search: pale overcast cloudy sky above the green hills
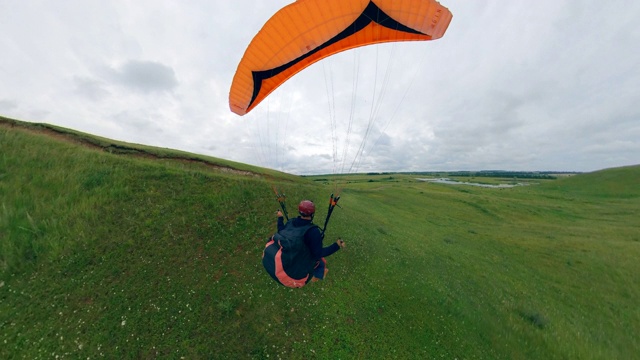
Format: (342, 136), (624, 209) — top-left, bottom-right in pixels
(0, 0), (640, 174)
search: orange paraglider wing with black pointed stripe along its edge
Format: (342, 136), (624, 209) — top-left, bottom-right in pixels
(229, 0), (452, 115)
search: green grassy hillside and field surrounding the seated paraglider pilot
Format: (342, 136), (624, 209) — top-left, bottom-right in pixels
(0, 119), (640, 359)
